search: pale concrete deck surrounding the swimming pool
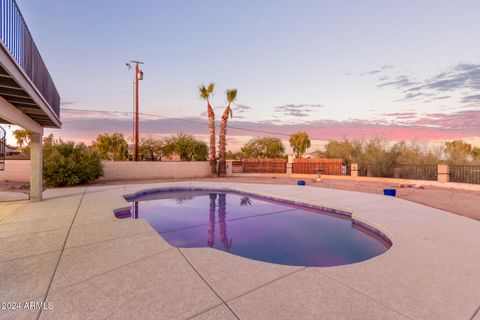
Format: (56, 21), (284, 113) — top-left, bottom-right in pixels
(0, 181), (480, 320)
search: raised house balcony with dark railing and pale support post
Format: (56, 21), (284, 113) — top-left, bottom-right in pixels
(0, 0), (61, 201)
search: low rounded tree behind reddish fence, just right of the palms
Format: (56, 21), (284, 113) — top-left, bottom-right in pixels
(241, 137), (285, 158)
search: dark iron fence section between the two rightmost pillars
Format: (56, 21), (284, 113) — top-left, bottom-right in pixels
(358, 163), (437, 180)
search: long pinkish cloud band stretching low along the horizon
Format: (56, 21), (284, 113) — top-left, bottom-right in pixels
(47, 110), (480, 143)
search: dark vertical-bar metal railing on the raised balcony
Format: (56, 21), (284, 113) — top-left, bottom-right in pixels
(0, 0), (60, 116)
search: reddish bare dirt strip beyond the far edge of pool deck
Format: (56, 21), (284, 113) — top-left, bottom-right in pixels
(0, 177), (480, 221)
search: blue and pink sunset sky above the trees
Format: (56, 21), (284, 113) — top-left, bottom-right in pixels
(5, 0), (480, 150)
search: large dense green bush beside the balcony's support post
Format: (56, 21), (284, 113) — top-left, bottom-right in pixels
(43, 140), (103, 187)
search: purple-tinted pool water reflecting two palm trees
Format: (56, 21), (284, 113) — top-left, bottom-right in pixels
(116, 191), (390, 267)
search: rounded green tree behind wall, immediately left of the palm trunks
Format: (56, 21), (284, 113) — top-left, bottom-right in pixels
(163, 133), (208, 161)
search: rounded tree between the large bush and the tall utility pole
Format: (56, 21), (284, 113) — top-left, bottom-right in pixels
(93, 133), (128, 161)
